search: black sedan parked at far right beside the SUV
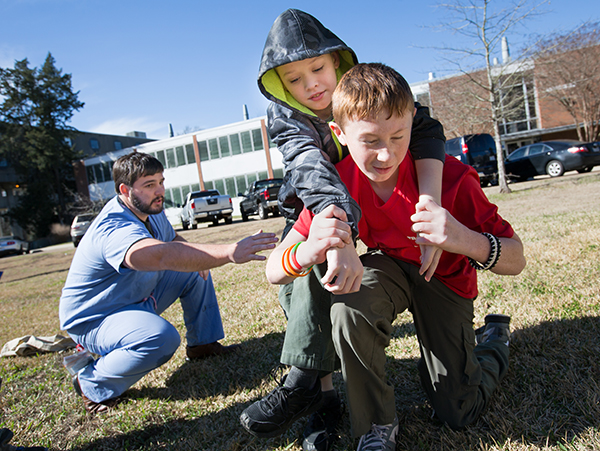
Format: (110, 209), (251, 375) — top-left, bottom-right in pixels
(504, 140), (600, 181)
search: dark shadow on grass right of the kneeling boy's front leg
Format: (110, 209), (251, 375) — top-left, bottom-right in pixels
(387, 317), (600, 450)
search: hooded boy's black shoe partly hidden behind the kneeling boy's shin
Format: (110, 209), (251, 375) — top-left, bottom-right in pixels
(302, 395), (344, 451)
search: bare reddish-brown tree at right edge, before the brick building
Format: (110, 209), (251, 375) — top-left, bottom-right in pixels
(534, 22), (600, 141)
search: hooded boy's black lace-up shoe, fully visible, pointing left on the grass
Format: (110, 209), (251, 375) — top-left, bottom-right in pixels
(240, 376), (323, 438)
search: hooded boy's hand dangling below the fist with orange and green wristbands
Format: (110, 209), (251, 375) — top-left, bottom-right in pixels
(321, 246), (364, 294)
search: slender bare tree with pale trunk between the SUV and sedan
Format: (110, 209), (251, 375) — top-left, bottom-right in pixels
(432, 0), (547, 193)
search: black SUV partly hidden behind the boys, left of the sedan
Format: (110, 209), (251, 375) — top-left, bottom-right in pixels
(446, 133), (498, 186)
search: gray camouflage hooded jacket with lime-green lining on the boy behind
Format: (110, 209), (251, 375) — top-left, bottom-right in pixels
(258, 9), (445, 236)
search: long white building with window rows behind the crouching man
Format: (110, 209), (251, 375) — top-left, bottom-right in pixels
(83, 117), (283, 224)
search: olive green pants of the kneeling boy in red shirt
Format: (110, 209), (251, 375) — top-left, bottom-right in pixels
(331, 251), (509, 436)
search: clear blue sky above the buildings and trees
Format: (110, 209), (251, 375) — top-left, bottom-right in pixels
(0, 0), (600, 139)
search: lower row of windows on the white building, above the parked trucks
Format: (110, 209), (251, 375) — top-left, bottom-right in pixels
(165, 169), (283, 207)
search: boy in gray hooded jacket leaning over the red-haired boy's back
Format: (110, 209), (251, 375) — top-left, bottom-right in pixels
(240, 9), (445, 450)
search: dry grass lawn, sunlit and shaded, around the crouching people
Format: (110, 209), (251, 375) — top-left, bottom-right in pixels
(0, 171), (600, 451)
